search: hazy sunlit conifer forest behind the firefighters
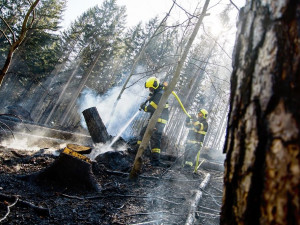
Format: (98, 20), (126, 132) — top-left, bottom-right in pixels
(0, 0), (237, 158)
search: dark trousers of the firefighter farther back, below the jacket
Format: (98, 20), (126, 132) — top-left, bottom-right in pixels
(183, 143), (202, 171)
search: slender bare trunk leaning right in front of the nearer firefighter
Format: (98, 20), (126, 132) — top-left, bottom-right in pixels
(130, 0), (209, 179)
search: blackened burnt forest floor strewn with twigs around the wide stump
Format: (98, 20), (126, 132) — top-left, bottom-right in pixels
(0, 147), (223, 225)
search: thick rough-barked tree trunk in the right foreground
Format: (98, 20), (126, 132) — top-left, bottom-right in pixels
(221, 0), (300, 225)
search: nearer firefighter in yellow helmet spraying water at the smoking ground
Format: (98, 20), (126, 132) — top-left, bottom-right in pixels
(137, 77), (169, 166)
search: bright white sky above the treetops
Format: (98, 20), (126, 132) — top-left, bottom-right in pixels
(62, 0), (245, 28)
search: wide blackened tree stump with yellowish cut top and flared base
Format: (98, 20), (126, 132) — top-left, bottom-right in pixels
(29, 148), (101, 192)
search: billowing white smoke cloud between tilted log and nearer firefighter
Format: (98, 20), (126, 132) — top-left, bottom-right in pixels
(77, 75), (148, 138)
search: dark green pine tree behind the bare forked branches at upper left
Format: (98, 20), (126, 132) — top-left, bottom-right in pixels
(0, 0), (65, 109)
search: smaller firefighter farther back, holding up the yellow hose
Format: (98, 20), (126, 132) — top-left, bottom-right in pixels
(183, 109), (208, 173)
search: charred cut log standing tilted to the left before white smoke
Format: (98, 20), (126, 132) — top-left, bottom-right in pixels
(82, 107), (110, 143)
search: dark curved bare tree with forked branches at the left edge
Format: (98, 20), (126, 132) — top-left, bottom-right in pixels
(0, 0), (40, 87)
